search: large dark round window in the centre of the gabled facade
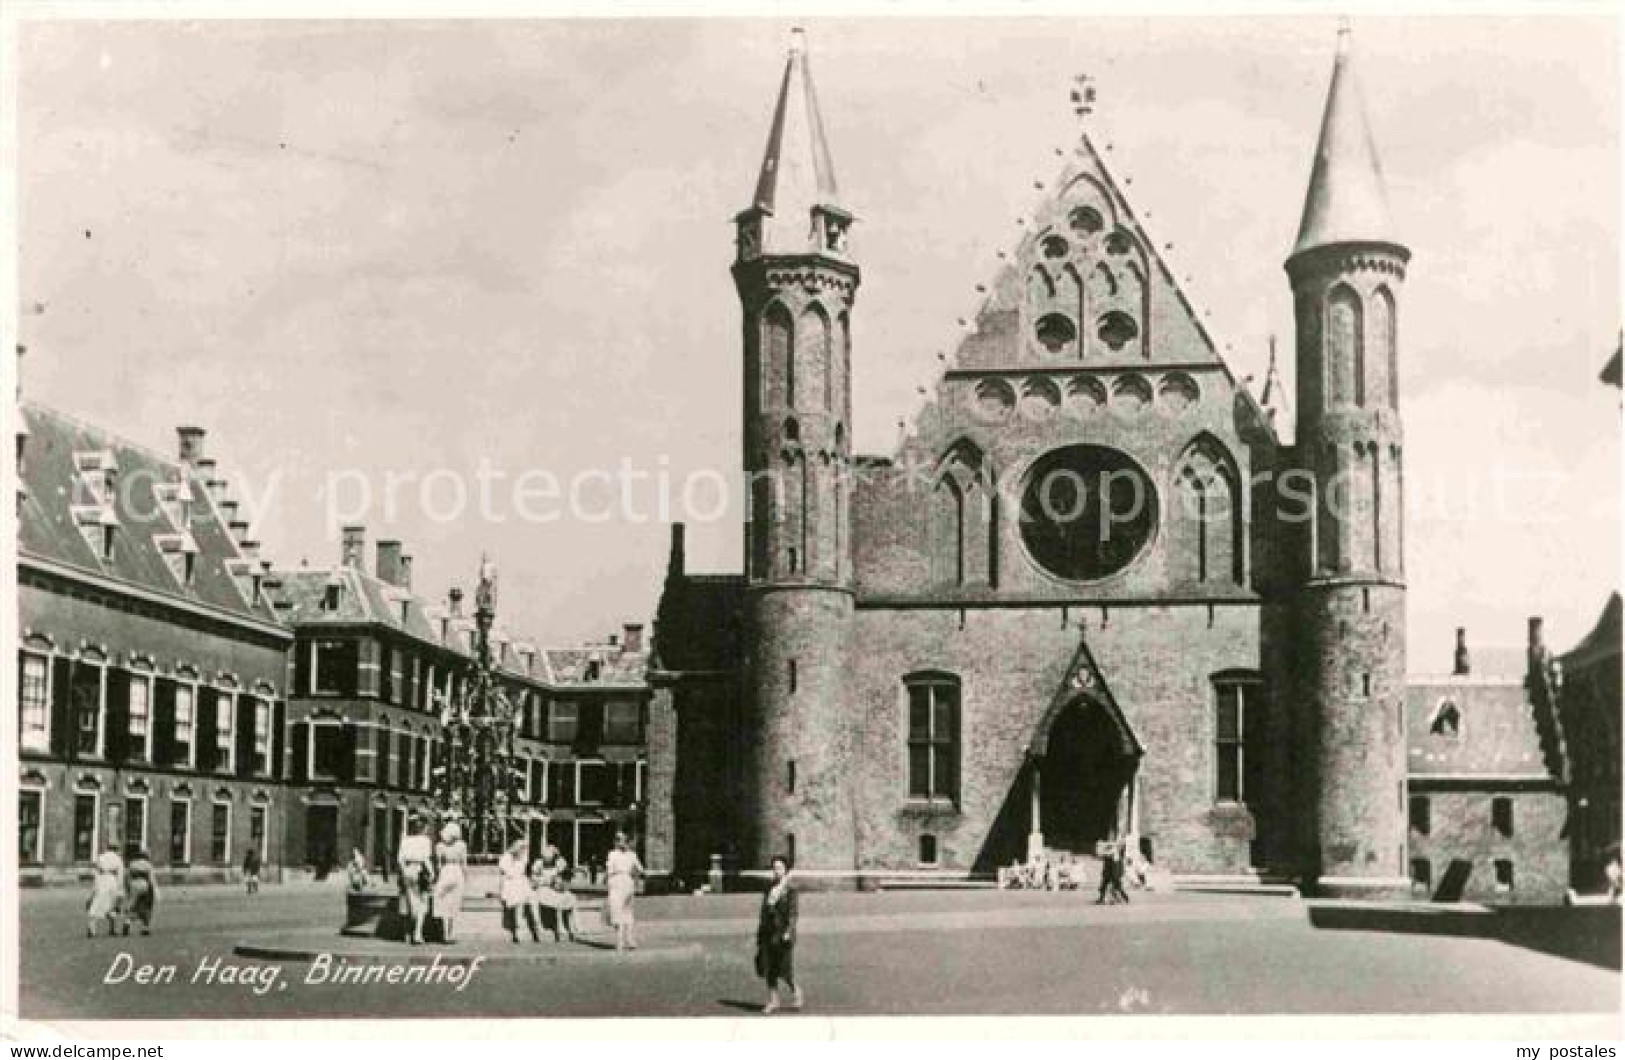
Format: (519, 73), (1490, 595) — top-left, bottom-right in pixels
(1021, 445), (1157, 582)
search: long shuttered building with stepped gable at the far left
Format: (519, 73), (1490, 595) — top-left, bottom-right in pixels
(16, 411), (293, 886)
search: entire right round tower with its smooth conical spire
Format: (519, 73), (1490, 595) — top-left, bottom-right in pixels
(1285, 26), (1411, 896)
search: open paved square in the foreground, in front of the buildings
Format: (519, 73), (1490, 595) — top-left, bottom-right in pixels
(9, 884), (1620, 1019)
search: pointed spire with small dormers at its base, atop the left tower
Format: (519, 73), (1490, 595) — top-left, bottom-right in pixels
(741, 28), (850, 254)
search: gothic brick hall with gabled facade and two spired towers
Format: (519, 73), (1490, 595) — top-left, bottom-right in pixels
(652, 29), (1411, 894)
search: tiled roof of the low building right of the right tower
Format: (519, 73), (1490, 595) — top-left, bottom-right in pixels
(1406, 676), (1552, 777)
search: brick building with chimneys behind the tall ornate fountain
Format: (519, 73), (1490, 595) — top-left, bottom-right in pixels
(278, 527), (648, 876)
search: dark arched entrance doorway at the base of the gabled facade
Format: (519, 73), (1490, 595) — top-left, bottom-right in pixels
(1027, 693), (1142, 855)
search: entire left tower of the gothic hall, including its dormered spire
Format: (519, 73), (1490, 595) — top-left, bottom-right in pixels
(733, 29), (858, 870)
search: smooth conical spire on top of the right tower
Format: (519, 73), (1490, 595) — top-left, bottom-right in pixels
(1292, 23), (1398, 255)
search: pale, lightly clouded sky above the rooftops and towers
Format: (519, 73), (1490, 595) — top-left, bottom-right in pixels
(16, 16), (1620, 671)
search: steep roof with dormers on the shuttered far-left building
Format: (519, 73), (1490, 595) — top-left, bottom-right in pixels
(18, 403), (276, 623)
